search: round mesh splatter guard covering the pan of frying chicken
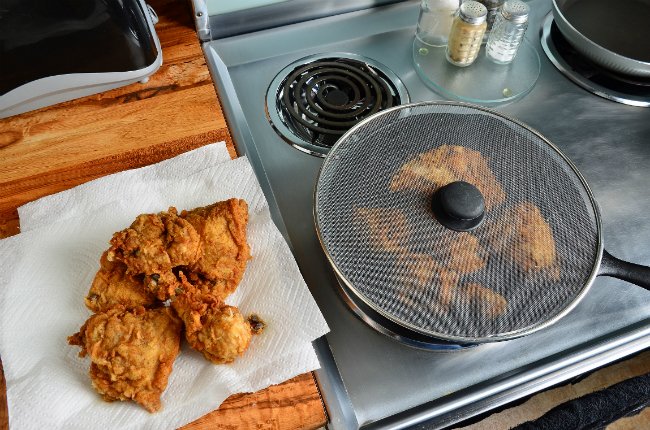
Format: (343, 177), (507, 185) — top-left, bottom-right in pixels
(315, 102), (602, 343)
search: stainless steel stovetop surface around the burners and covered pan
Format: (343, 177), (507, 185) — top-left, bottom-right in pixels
(204, 0), (650, 429)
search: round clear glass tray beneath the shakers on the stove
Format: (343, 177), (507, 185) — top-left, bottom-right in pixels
(413, 38), (540, 105)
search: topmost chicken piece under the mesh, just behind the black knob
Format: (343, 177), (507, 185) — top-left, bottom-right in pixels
(390, 145), (506, 210)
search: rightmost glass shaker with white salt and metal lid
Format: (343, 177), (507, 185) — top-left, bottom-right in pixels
(485, 0), (529, 64)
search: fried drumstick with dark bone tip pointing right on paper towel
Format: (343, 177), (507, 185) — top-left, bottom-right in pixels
(172, 277), (254, 364)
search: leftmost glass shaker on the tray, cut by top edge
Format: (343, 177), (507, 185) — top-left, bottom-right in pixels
(415, 0), (460, 47)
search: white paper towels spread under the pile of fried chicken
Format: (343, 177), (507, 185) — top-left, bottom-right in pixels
(0, 146), (328, 429)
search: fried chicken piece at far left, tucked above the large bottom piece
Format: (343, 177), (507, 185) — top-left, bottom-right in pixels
(84, 251), (157, 312)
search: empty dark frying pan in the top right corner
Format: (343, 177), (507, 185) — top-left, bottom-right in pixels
(553, 0), (650, 78)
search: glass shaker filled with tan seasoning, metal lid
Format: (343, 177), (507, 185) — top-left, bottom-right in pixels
(446, 0), (487, 67)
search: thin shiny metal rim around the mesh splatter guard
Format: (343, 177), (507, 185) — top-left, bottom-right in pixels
(313, 101), (603, 344)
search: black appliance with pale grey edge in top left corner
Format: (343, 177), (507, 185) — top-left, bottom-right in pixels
(0, 0), (162, 118)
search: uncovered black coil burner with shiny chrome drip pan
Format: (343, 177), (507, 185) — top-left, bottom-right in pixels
(266, 54), (409, 157)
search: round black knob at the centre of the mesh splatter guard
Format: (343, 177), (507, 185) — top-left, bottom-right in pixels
(431, 181), (485, 231)
